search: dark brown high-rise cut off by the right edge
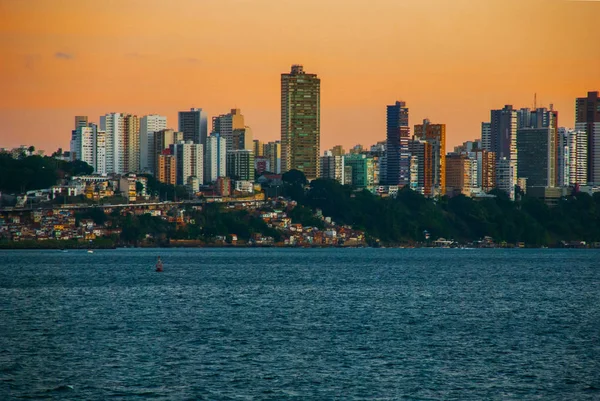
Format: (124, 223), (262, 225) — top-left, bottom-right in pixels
(575, 92), (600, 185)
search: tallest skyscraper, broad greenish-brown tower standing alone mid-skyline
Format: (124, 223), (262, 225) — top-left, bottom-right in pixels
(281, 65), (321, 180)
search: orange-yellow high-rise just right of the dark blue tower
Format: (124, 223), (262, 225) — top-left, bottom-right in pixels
(414, 119), (446, 195)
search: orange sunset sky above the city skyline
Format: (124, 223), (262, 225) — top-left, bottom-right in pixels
(0, 0), (600, 152)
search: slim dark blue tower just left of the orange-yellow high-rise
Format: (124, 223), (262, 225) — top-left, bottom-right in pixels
(385, 101), (410, 186)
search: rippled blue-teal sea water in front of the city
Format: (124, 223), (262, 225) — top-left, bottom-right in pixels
(0, 249), (600, 400)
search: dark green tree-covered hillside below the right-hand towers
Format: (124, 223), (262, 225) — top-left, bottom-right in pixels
(284, 170), (600, 246)
